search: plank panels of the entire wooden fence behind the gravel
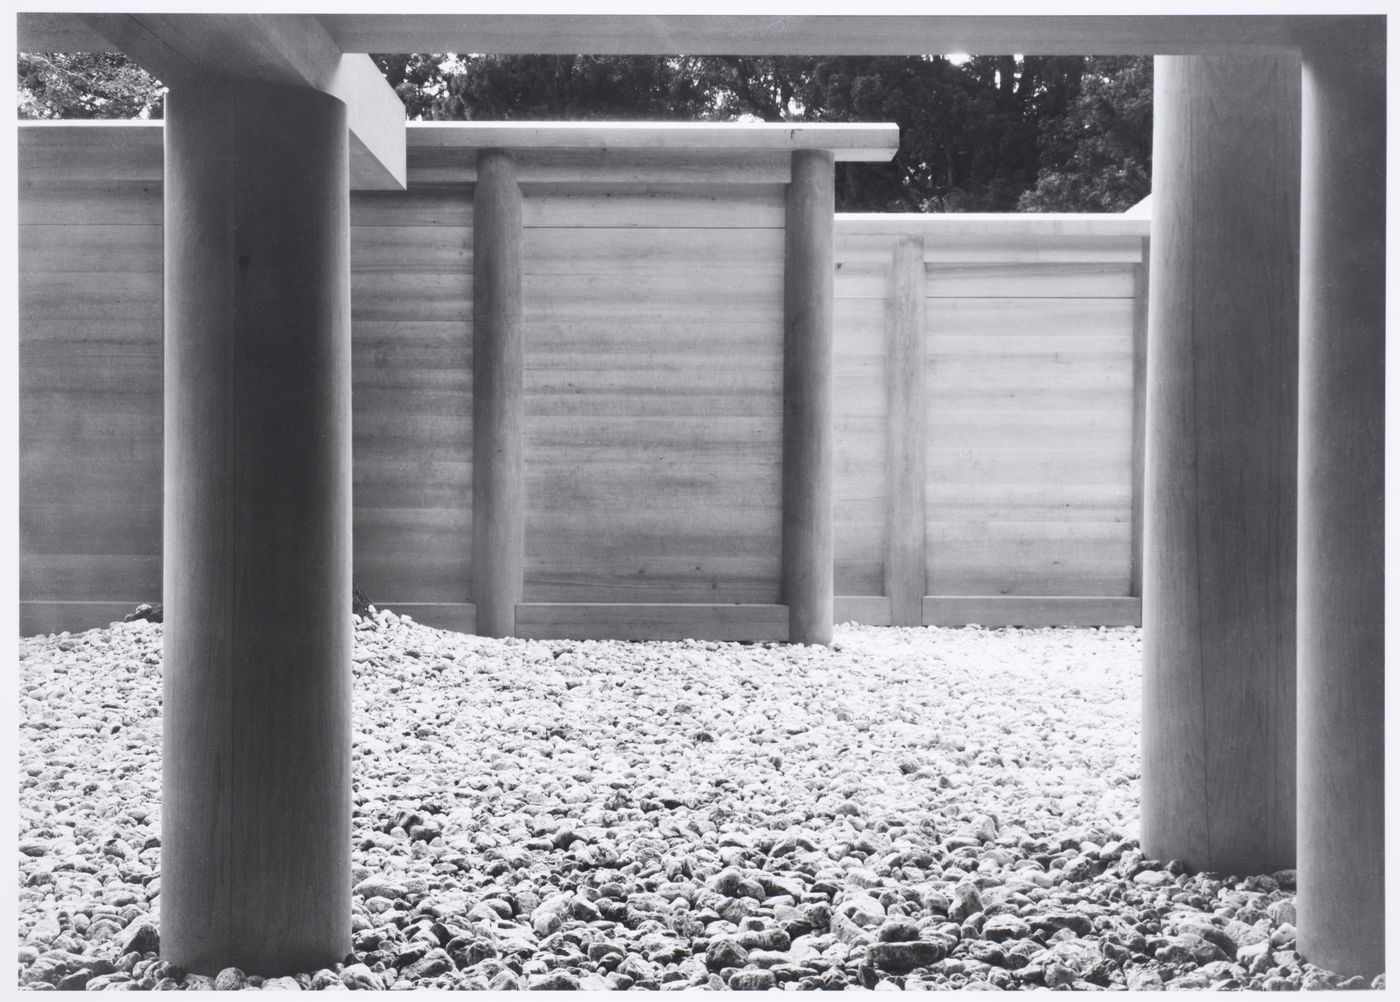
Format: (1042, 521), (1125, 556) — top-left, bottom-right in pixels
(20, 126), (1147, 640)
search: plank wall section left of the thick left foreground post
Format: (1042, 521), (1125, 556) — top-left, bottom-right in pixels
(18, 129), (164, 634)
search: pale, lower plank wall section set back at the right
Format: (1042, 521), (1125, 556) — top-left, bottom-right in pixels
(836, 216), (1147, 626)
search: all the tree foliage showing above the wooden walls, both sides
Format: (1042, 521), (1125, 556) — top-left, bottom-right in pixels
(20, 53), (1152, 211)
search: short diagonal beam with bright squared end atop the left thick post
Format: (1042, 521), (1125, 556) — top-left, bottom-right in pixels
(73, 14), (406, 189)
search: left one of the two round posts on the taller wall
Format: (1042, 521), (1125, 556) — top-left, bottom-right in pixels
(472, 150), (525, 637)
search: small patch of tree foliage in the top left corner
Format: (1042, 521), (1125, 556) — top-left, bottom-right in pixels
(18, 52), (165, 119)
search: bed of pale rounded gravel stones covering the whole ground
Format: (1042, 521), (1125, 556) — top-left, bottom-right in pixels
(18, 612), (1383, 989)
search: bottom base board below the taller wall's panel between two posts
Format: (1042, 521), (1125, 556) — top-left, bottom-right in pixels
(515, 602), (788, 642)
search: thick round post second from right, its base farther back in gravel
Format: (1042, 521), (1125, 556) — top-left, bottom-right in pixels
(1141, 55), (1299, 873)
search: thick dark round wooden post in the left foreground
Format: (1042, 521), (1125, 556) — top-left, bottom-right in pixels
(161, 84), (353, 975)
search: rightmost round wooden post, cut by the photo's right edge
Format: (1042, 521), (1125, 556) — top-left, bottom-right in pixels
(1298, 17), (1386, 975)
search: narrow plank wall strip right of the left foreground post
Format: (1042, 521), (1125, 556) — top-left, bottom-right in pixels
(350, 183), (476, 630)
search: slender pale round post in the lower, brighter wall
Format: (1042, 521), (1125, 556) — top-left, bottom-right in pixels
(885, 237), (928, 626)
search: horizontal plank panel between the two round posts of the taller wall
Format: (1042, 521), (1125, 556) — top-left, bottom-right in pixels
(524, 178), (784, 619)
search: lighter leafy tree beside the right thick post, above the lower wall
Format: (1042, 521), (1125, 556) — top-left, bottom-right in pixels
(1016, 56), (1152, 213)
